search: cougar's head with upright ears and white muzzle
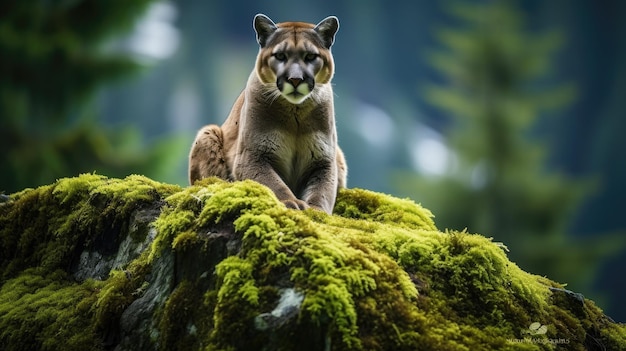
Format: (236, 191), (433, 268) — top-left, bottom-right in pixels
(254, 14), (339, 104)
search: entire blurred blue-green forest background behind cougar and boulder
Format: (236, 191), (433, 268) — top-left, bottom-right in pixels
(0, 0), (626, 322)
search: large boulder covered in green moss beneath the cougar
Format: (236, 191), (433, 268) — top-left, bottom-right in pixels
(0, 174), (626, 351)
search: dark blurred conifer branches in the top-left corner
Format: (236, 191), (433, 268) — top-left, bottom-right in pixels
(0, 0), (151, 115)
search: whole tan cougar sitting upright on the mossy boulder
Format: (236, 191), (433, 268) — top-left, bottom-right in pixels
(189, 15), (347, 213)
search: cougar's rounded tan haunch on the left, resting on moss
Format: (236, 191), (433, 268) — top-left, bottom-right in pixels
(189, 124), (232, 184)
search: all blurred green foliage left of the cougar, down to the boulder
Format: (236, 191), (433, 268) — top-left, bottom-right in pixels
(0, 0), (187, 192)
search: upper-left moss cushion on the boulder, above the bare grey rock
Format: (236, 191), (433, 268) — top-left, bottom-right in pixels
(0, 174), (180, 279)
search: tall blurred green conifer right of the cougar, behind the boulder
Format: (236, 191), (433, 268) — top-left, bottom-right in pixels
(394, 1), (626, 302)
